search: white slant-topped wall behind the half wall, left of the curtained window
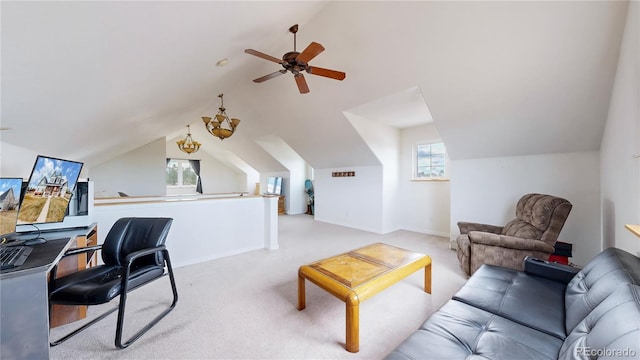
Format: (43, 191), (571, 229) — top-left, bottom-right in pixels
(88, 138), (167, 196)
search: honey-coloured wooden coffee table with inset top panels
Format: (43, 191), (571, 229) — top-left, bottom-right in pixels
(298, 243), (431, 353)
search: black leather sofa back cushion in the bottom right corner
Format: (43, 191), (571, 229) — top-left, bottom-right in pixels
(558, 285), (640, 360)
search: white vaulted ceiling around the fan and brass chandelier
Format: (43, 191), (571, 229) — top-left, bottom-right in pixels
(0, 1), (627, 171)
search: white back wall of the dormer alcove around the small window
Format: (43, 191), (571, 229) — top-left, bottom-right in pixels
(397, 124), (451, 238)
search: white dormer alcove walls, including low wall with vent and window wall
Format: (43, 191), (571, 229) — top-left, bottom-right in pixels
(314, 122), (450, 237)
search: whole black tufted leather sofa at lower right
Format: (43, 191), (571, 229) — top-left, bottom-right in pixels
(387, 248), (640, 360)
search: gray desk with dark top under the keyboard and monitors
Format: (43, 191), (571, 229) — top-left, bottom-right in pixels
(0, 224), (95, 360)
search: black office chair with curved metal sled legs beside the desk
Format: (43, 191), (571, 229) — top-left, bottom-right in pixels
(49, 217), (178, 349)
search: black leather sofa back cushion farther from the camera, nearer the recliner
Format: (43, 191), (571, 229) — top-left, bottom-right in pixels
(565, 248), (640, 333)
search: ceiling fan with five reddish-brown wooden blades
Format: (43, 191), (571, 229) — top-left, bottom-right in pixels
(244, 24), (346, 94)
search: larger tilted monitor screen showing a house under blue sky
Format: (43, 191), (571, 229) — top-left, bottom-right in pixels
(17, 155), (83, 225)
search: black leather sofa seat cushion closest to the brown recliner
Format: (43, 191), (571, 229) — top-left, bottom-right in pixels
(453, 265), (566, 339)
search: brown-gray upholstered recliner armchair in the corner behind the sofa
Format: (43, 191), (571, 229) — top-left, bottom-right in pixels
(457, 194), (573, 275)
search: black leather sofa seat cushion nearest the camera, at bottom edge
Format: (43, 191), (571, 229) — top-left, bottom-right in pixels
(386, 300), (562, 360)
